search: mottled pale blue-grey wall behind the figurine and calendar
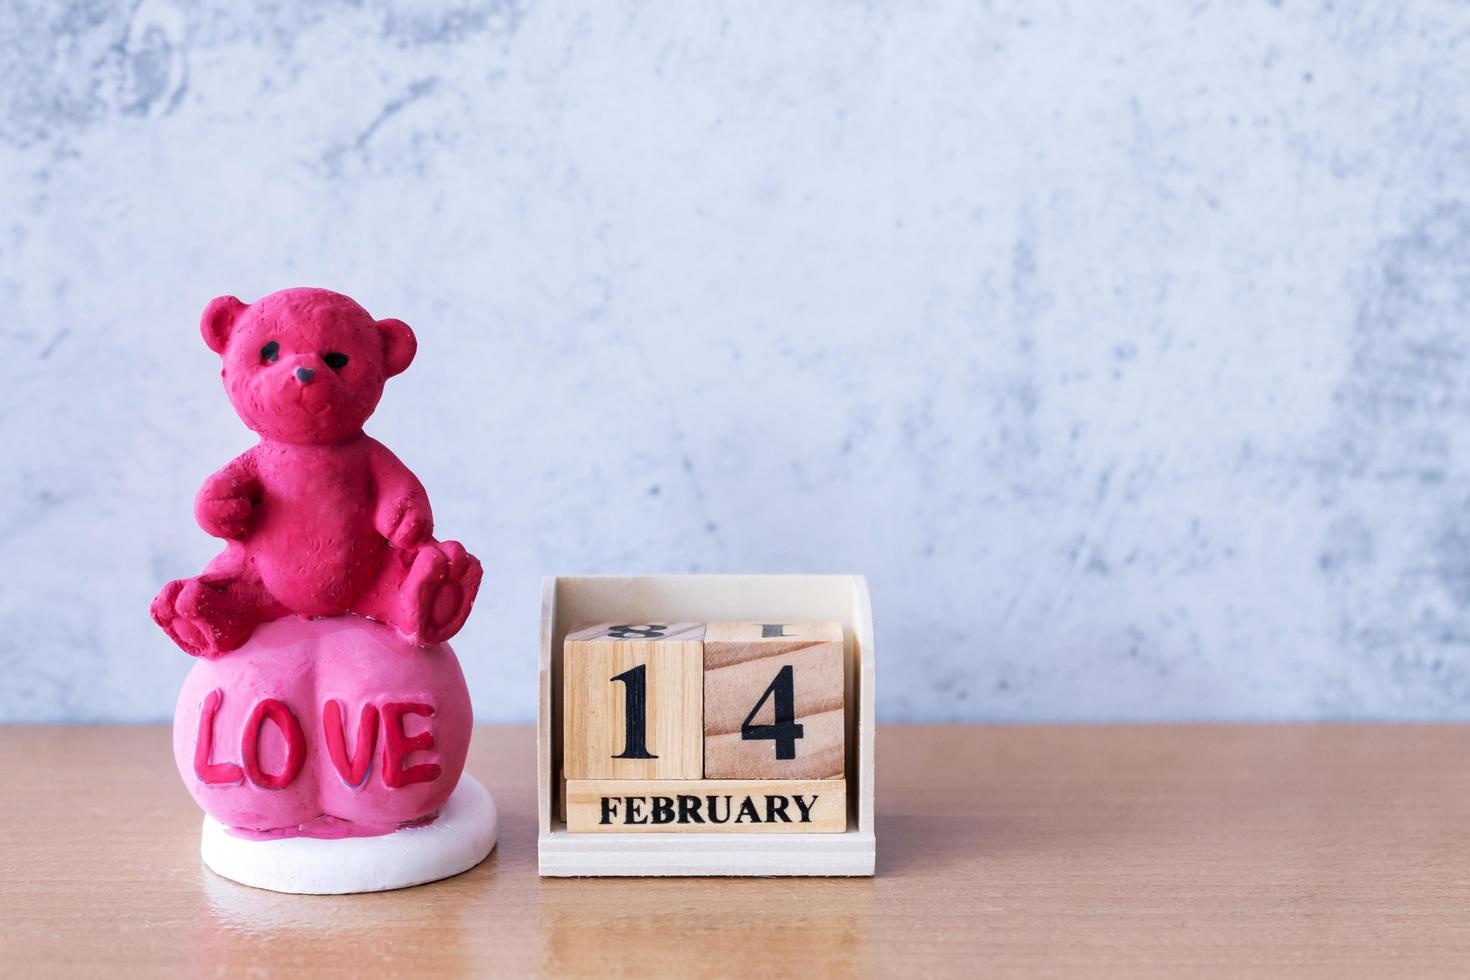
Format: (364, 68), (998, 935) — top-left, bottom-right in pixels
(0, 0), (1470, 720)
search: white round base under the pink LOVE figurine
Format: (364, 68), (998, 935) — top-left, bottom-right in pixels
(198, 774), (495, 895)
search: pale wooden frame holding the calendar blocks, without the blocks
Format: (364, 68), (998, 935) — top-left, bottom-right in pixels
(537, 574), (876, 877)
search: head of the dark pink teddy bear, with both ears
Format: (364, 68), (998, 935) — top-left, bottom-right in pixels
(200, 288), (417, 444)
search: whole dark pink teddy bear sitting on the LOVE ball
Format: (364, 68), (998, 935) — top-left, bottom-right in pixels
(151, 289), (481, 658)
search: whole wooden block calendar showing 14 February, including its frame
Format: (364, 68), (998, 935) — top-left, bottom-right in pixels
(538, 576), (875, 876)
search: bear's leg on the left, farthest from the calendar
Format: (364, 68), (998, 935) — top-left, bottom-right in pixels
(150, 551), (287, 658)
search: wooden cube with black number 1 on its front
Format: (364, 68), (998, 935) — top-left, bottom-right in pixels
(562, 623), (704, 780)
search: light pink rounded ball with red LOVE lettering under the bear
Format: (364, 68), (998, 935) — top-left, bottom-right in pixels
(173, 616), (473, 837)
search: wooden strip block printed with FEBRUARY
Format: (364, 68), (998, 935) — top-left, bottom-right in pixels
(564, 779), (847, 833)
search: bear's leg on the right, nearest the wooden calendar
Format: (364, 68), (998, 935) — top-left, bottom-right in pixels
(354, 541), (482, 646)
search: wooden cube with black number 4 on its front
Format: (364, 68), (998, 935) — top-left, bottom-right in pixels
(704, 623), (847, 779)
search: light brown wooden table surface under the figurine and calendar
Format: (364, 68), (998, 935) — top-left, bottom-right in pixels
(0, 726), (1470, 977)
